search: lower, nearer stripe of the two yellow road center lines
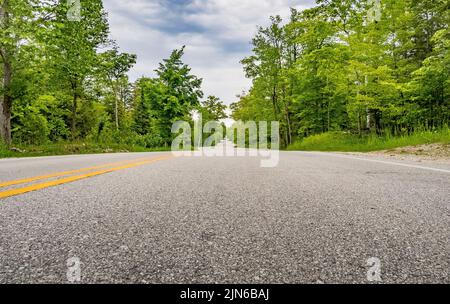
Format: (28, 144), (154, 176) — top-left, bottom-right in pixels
(0, 156), (173, 199)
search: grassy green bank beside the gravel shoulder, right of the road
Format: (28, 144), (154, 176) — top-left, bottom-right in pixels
(287, 128), (450, 152)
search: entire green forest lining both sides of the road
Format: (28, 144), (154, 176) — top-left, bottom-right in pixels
(0, 0), (450, 156)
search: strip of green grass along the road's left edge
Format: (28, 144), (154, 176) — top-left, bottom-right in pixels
(0, 142), (170, 158)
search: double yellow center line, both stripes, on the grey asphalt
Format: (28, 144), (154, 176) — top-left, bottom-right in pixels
(0, 155), (173, 199)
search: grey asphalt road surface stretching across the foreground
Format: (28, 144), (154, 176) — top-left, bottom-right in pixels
(0, 152), (450, 283)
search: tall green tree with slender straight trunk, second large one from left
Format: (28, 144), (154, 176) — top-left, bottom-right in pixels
(46, 0), (109, 138)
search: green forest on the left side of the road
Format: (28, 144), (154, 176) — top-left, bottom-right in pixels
(0, 0), (226, 152)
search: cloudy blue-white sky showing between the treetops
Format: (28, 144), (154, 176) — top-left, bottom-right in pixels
(104, 0), (314, 104)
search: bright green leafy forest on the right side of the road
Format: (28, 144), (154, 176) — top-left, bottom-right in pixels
(231, 0), (450, 147)
